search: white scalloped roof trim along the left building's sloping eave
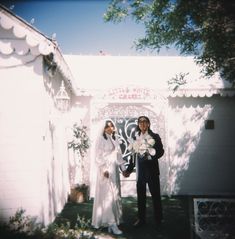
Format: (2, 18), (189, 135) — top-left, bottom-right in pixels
(0, 4), (77, 94)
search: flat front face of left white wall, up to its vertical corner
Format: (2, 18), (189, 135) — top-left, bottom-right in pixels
(0, 54), (44, 220)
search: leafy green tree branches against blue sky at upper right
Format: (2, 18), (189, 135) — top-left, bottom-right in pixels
(104, 0), (235, 86)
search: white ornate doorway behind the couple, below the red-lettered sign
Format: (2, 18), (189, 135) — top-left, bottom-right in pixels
(90, 101), (169, 197)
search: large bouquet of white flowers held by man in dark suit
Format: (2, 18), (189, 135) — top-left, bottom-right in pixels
(128, 135), (156, 156)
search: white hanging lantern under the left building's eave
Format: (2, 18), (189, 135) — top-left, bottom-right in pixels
(55, 80), (70, 112)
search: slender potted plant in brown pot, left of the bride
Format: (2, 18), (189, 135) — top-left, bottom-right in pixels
(68, 124), (90, 203)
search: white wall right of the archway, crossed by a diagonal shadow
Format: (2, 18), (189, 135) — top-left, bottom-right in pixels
(169, 96), (235, 195)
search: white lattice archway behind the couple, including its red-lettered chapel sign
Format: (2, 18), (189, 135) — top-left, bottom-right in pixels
(90, 86), (169, 196)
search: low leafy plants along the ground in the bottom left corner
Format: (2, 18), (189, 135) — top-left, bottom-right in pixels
(0, 209), (94, 239)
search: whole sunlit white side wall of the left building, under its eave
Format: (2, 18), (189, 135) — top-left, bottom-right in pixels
(0, 23), (73, 224)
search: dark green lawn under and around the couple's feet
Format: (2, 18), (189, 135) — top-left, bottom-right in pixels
(55, 197), (191, 239)
